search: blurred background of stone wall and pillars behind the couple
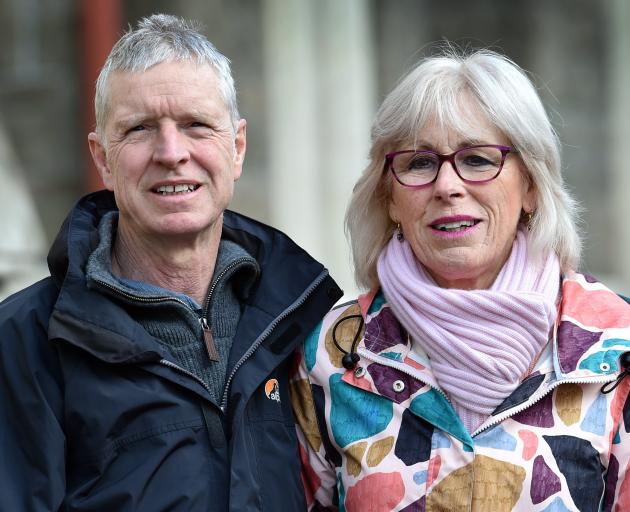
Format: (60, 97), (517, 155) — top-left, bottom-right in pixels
(0, 0), (630, 298)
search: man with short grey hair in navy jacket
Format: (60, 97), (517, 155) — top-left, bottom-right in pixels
(0, 15), (341, 512)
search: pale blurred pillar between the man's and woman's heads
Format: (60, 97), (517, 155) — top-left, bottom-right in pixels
(264, 0), (376, 297)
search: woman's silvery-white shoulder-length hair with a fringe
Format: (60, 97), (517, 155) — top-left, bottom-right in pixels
(346, 48), (582, 288)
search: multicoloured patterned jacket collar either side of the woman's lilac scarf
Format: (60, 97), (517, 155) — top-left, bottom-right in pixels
(358, 272), (630, 385)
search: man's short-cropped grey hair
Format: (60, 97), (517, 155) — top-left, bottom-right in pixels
(94, 14), (240, 137)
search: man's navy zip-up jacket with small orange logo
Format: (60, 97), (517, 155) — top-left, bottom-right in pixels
(0, 192), (341, 512)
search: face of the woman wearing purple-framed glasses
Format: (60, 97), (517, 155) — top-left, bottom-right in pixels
(389, 108), (535, 290)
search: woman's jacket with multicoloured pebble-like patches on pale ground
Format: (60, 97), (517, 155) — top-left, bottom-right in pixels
(292, 274), (630, 512)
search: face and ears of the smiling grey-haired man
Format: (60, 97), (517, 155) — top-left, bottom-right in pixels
(88, 61), (245, 244)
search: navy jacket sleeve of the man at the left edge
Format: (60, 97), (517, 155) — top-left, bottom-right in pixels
(0, 290), (66, 512)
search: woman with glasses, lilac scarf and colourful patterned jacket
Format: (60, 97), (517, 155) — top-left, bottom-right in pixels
(293, 51), (630, 512)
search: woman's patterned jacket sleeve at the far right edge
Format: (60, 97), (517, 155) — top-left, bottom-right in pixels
(602, 377), (630, 512)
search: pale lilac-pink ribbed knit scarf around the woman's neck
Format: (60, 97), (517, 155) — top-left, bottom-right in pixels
(377, 231), (560, 433)
